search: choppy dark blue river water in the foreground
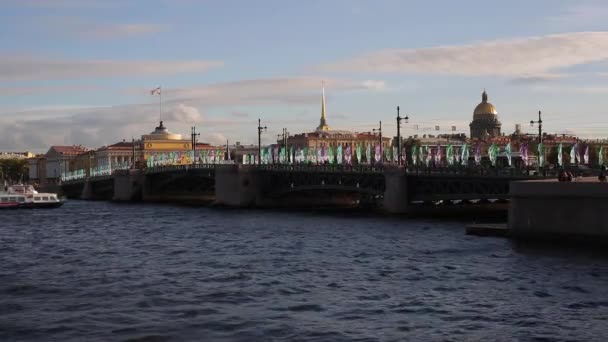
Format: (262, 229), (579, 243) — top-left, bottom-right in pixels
(0, 202), (608, 341)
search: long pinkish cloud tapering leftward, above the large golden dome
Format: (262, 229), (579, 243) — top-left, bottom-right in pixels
(318, 32), (608, 78)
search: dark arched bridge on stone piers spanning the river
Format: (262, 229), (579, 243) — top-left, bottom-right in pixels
(55, 164), (556, 213)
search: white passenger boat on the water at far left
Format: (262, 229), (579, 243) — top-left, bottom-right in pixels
(0, 184), (63, 209)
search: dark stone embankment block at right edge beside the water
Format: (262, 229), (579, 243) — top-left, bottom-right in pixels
(509, 177), (608, 242)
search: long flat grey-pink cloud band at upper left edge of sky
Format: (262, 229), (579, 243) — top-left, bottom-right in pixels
(0, 55), (223, 82)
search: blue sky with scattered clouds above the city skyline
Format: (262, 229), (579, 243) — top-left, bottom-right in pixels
(0, 0), (608, 152)
